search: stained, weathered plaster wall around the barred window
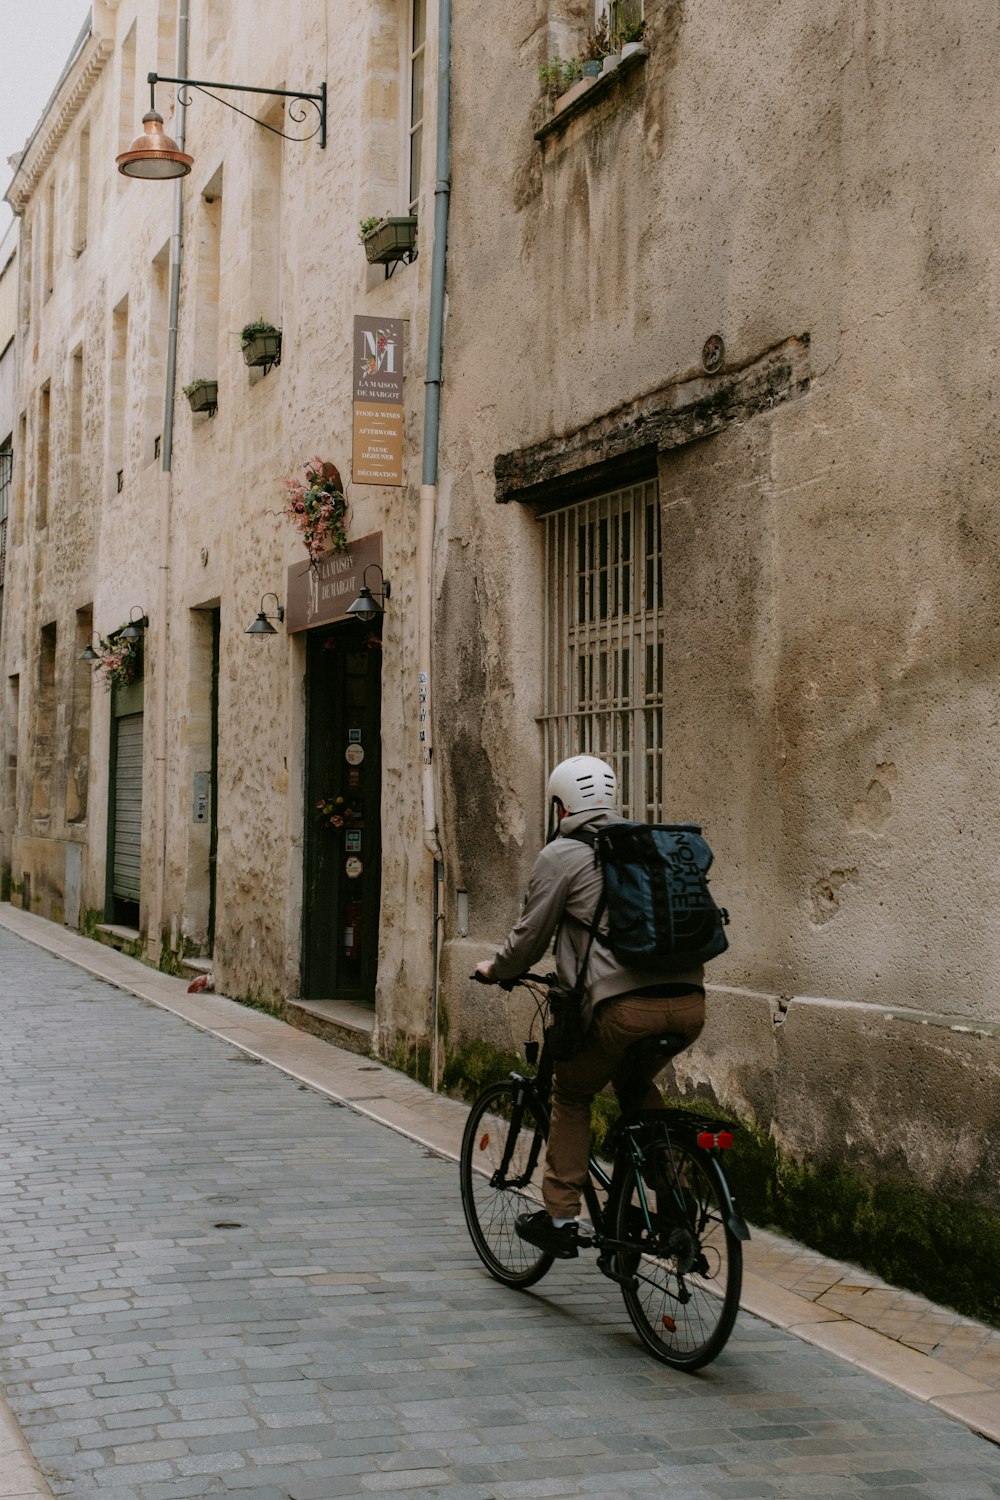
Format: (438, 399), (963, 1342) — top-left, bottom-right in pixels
(438, 0), (1000, 1187)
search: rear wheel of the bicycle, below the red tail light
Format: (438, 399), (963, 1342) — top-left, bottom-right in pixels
(610, 1139), (744, 1371)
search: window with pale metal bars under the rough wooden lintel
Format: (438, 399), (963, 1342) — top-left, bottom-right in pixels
(540, 480), (663, 822)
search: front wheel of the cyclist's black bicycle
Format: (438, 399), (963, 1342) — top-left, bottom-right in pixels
(460, 1079), (553, 1287)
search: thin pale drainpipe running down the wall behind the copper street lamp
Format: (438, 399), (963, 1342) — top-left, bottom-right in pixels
(147, 0), (189, 959)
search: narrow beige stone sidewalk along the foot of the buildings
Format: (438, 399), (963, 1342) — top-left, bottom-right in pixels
(0, 906), (1000, 1500)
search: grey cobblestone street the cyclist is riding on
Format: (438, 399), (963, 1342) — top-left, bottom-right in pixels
(0, 930), (1000, 1500)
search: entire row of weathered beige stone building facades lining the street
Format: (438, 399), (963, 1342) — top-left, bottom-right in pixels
(0, 0), (1000, 1242)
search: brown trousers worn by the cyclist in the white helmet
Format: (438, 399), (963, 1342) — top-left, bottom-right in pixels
(541, 990), (705, 1218)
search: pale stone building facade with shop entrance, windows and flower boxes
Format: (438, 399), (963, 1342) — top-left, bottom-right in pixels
(0, 0), (433, 1056)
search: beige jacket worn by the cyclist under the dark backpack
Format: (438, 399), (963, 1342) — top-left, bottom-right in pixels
(490, 812), (705, 1026)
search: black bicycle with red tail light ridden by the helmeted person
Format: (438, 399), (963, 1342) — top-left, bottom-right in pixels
(460, 974), (750, 1371)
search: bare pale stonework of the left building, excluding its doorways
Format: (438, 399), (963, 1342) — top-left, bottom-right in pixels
(3, 0), (435, 1040)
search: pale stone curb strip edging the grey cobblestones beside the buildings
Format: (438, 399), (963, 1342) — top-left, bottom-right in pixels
(0, 903), (1000, 1470)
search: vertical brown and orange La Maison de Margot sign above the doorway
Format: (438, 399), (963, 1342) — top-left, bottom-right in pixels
(351, 318), (403, 485)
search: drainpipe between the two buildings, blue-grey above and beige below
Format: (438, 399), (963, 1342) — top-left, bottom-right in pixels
(417, 0), (451, 1091)
